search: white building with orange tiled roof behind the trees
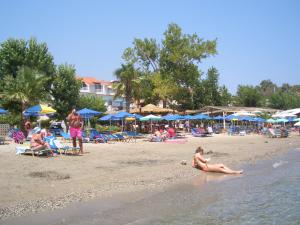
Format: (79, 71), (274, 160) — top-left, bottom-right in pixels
(77, 77), (125, 111)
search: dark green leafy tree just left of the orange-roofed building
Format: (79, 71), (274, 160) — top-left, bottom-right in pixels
(51, 64), (82, 120)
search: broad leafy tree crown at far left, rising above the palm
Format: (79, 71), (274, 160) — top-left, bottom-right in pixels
(0, 38), (55, 79)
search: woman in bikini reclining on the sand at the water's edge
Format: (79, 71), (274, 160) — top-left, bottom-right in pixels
(192, 147), (243, 174)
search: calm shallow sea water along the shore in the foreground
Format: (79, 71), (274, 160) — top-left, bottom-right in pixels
(5, 149), (300, 225)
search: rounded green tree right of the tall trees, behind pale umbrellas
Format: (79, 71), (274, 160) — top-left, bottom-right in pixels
(237, 85), (262, 107)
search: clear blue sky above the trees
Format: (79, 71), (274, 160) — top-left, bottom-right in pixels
(0, 0), (300, 93)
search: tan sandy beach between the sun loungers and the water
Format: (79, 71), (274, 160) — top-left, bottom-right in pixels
(0, 134), (300, 220)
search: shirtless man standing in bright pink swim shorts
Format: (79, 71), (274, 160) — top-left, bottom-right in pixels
(67, 109), (83, 154)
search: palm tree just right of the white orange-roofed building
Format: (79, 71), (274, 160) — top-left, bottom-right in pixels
(113, 64), (142, 112)
